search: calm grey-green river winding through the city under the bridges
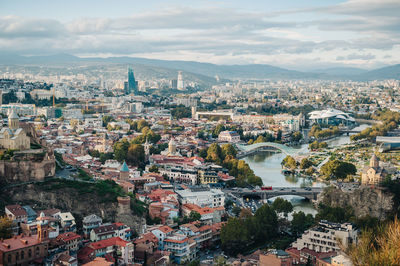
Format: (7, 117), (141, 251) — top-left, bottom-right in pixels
(243, 124), (369, 215)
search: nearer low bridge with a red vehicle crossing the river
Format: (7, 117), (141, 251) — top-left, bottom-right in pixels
(231, 187), (324, 200)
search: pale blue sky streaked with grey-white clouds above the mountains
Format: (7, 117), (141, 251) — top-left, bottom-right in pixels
(0, 0), (400, 70)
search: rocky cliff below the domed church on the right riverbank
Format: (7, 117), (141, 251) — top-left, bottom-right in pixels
(317, 187), (394, 220)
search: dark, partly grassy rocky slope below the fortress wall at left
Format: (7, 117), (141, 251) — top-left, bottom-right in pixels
(0, 184), (145, 232)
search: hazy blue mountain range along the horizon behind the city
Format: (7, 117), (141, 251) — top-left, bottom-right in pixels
(0, 53), (400, 80)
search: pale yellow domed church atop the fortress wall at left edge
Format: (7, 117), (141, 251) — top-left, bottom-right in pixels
(0, 110), (31, 150)
